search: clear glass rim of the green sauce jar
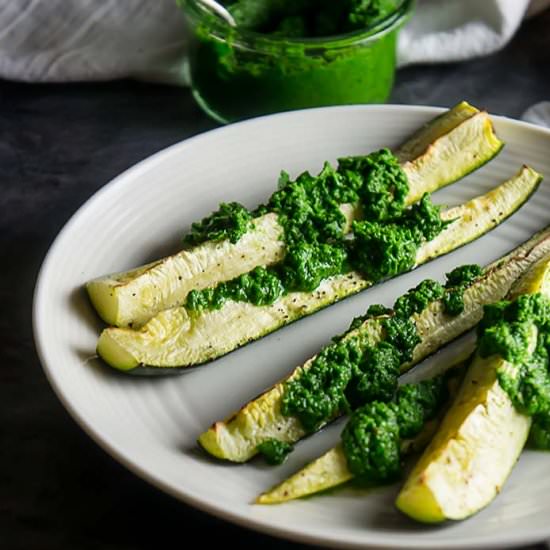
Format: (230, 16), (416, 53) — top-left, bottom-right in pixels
(177, 0), (415, 50)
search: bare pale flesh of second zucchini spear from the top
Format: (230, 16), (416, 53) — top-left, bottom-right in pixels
(97, 167), (541, 374)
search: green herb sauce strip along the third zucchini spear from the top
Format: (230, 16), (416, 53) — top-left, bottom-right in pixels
(281, 266), (482, 431)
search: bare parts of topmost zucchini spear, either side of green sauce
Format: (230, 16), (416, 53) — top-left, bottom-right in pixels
(86, 102), (503, 328)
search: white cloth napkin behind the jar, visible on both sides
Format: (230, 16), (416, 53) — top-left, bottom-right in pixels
(0, 0), (550, 84)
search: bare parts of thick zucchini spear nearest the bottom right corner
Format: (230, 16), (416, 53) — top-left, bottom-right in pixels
(396, 256), (550, 523)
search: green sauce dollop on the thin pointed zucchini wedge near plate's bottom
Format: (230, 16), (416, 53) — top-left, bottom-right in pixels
(341, 375), (447, 483)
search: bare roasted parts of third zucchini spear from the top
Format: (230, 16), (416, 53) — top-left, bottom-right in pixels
(199, 213), (550, 462)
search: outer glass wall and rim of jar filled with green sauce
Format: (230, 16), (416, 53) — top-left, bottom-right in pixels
(179, 0), (414, 123)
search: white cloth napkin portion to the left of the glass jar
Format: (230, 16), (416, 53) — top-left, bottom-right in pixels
(0, 0), (185, 83)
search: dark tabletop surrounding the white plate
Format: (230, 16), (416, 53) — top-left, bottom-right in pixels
(4, 12), (550, 550)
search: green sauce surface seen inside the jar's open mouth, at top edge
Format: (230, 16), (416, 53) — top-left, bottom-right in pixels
(222, 0), (399, 38)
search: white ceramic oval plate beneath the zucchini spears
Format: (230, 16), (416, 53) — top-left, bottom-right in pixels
(34, 106), (550, 548)
